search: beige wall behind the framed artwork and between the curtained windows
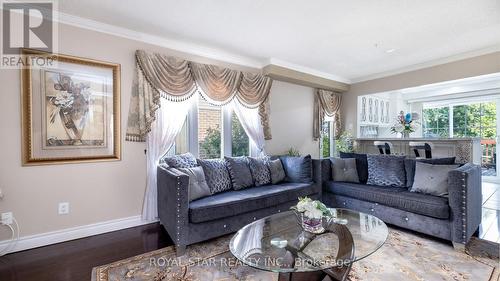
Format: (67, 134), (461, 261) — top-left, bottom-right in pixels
(0, 25), (318, 240)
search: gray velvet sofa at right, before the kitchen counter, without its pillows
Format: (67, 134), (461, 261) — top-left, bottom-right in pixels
(321, 159), (482, 247)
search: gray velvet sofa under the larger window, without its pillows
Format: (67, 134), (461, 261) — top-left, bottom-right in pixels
(158, 160), (322, 253)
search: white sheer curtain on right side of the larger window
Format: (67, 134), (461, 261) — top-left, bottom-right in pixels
(231, 99), (266, 155)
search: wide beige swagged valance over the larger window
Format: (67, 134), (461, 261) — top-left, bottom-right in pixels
(126, 50), (272, 142)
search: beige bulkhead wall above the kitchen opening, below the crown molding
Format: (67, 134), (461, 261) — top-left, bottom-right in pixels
(343, 52), (500, 135)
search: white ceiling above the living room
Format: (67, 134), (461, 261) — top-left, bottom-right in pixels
(58, 0), (500, 82)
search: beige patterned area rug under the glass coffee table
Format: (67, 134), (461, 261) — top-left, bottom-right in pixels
(92, 228), (500, 281)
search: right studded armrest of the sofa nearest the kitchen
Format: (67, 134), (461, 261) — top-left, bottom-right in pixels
(448, 163), (482, 244)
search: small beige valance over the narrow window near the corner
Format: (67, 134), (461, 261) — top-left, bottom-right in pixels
(313, 89), (342, 140)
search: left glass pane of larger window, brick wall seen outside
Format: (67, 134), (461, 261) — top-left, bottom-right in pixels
(198, 98), (222, 159)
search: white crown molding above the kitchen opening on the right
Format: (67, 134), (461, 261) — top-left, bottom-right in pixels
(351, 44), (500, 83)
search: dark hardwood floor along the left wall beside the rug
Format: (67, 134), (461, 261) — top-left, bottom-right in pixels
(0, 223), (172, 281)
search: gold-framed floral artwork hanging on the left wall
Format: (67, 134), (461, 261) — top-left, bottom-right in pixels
(21, 49), (121, 166)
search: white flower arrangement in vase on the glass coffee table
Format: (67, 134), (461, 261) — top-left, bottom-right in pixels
(290, 197), (331, 233)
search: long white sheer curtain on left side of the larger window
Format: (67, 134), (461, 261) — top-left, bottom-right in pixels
(142, 98), (193, 220)
